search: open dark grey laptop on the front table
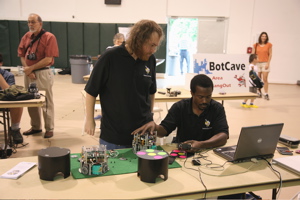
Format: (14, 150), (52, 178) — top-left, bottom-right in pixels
(213, 123), (283, 163)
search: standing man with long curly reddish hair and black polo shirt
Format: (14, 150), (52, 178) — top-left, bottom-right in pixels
(85, 20), (164, 149)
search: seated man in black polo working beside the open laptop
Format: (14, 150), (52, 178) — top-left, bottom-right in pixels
(132, 74), (229, 152)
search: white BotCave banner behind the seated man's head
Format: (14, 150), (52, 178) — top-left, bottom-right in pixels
(185, 54), (250, 93)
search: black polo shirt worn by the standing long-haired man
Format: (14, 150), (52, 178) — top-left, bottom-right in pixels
(85, 44), (156, 145)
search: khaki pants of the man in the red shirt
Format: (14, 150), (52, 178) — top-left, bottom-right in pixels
(24, 69), (54, 131)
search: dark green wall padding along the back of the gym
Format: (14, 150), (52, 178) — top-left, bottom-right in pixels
(0, 20), (167, 73)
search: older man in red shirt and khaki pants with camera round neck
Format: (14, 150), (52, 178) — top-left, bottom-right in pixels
(18, 13), (59, 138)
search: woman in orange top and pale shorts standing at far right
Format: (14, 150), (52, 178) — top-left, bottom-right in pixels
(253, 32), (273, 100)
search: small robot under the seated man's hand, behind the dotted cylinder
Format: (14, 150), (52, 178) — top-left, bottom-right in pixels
(132, 131), (157, 153)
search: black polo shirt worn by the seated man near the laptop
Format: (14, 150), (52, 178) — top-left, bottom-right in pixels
(160, 98), (229, 143)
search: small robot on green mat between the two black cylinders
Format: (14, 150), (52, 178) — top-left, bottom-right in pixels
(79, 144), (109, 175)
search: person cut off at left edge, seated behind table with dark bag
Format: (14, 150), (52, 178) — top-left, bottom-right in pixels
(0, 54), (23, 144)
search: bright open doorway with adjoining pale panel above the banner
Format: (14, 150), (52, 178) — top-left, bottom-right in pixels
(166, 17), (228, 76)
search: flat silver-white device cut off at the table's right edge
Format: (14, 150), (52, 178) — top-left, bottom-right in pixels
(273, 156), (300, 176)
